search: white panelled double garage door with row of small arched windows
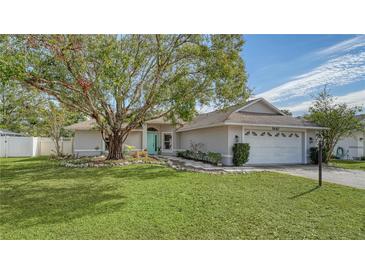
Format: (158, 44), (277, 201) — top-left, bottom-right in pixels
(243, 130), (303, 164)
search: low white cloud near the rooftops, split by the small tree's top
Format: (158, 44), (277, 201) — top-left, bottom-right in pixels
(285, 89), (365, 112)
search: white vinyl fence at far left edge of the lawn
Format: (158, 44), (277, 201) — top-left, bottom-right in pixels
(0, 136), (73, 157)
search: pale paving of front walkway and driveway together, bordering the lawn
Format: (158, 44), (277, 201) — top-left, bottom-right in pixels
(159, 156), (365, 189)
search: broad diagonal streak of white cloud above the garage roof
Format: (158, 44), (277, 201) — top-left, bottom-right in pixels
(259, 51), (365, 102)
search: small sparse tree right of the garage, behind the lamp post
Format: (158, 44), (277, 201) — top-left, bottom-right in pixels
(306, 89), (363, 162)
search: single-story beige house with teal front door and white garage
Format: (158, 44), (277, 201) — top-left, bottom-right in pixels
(68, 98), (323, 165)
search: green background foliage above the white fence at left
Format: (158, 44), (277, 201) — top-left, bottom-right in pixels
(0, 82), (85, 140)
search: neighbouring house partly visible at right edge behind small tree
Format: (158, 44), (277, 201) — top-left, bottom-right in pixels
(333, 114), (365, 160)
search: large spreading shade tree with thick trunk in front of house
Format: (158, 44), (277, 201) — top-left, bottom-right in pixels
(0, 35), (248, 159)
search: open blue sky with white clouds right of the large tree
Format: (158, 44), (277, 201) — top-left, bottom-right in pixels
(242, 35), (365, 116)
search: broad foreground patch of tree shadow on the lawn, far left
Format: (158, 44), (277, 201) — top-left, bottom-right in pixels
(0, 180), (126, 228)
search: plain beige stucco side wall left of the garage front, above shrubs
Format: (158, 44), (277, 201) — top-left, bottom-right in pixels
(180, 126), (228, 155)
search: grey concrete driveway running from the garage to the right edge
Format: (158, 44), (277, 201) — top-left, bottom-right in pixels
(263, 165), (365, 189)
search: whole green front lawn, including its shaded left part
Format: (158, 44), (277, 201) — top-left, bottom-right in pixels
(0, 158), (365, 239)
